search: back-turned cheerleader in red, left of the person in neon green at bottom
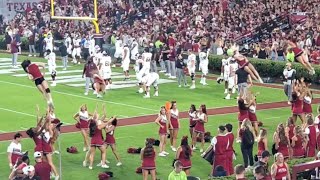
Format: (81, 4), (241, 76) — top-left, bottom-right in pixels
(140, 139), (156, 180)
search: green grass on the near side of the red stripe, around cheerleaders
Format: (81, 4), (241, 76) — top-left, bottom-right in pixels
(0, 107), (315, 180)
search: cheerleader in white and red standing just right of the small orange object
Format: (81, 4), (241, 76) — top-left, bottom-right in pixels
(169, 101), (180, 152)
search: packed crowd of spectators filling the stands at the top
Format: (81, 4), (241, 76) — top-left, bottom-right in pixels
(1, 0), (320, 63)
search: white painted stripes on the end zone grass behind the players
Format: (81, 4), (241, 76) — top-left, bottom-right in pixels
(0, 58), (175, 89)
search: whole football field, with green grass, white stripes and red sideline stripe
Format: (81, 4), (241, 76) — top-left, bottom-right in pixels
(0, 54), (319, 180)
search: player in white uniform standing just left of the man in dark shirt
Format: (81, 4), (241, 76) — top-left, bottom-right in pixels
(225, 58), (238, 99)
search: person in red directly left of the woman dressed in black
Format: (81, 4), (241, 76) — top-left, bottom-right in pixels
(225, 124), (235, 175)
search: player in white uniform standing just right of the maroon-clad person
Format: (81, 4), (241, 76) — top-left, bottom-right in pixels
(99, 51), (112, 89)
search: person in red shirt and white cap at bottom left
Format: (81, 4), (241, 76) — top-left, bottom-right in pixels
(34, 151), (51, 180)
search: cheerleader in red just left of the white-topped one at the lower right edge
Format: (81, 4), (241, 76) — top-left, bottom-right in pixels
(291, 126), (307, 158)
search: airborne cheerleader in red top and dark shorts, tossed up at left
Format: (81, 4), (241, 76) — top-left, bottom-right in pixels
(21, 60), (53, 107)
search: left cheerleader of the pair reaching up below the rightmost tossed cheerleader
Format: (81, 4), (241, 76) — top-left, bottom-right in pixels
(292, 85), (305, 124)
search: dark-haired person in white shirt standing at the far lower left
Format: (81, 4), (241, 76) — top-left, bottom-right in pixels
(7, 133), (23, 169)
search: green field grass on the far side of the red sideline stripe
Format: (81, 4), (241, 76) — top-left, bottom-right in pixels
(0, 54), (286, 132)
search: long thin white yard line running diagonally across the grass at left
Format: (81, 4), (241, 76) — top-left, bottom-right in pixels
(0, 80), (158, 112)
